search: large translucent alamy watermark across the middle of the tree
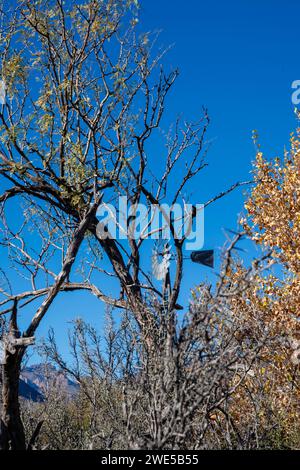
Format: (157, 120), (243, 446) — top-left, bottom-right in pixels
(97, 196), (204, 250)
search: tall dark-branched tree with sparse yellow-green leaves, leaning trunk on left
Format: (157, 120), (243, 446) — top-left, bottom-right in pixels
(0, 0), (250, 449)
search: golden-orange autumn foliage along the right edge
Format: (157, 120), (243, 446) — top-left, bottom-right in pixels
(227, 129), (300, 444)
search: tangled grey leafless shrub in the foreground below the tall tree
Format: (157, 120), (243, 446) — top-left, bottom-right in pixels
(31, 236), (270, 449)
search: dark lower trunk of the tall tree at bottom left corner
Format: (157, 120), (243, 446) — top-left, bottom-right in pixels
(0, 352), (26, 450)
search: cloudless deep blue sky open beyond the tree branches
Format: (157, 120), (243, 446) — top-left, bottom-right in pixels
(3, 0), (300, 364)
